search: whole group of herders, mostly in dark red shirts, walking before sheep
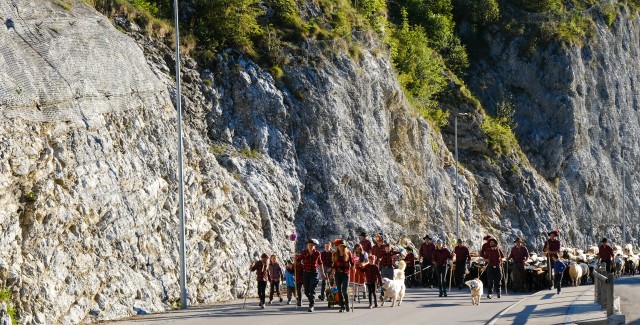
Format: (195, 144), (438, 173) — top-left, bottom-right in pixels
(250, 230), (624, 312)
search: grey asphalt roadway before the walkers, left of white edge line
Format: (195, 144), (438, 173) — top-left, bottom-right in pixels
(113, 288), (528, 325)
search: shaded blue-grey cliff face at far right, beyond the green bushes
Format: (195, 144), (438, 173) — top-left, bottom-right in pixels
(464, 8), (640, 246)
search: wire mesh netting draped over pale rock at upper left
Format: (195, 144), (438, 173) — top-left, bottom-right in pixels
(0, 0), (167, 124)
